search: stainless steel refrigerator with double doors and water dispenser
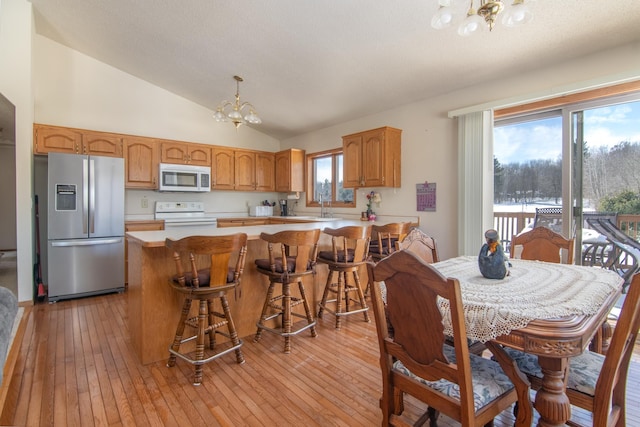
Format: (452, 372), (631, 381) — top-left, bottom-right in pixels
(47, 153), (125, 302)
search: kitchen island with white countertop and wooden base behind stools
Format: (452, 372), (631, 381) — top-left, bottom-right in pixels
(127, 217), (417, 364)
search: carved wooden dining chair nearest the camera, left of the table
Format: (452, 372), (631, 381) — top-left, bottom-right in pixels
(368, 251), (517, 426)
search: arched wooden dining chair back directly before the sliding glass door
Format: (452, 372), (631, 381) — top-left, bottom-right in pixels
(510, 227), (573, 264)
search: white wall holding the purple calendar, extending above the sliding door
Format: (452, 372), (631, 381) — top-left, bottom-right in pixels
(282, 43), (640, 258)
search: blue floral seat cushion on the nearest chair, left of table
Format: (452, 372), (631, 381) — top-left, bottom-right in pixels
(393, 345), (513, 412)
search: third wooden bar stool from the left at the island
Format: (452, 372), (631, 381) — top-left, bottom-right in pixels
(318, 226), (371, 329)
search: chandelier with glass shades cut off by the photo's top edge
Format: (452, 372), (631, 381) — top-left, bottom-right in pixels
(431, 0), (533, 37)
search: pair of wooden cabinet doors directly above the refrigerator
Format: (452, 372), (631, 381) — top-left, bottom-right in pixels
(33, 124), (123, 157)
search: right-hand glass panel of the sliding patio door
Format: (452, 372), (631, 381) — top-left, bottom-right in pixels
(570, 95), (640, 260)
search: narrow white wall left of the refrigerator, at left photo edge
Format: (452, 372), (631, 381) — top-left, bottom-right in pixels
(0, 0), (33, 302)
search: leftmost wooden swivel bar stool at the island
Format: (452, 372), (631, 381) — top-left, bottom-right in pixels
(165, 233), (247, 385)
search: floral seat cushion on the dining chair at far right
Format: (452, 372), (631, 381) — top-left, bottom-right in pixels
(505, 348), (604, 396)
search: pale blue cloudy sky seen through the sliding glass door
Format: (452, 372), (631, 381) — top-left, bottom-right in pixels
(493, 101), (640, 165)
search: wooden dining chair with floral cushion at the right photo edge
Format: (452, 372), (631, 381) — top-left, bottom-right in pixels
(506, 274), (640, 427)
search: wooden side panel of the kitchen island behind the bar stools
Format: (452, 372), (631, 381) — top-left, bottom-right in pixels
(127, 229), (344, 364)
